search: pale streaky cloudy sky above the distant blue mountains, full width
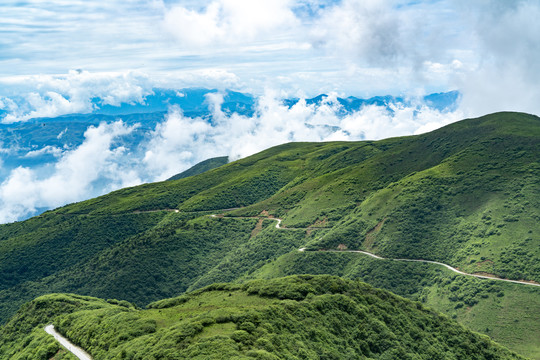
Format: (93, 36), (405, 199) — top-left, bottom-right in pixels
(0, 0), (540, 112)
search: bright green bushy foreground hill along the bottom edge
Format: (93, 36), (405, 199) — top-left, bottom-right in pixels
(0, 276), (520, 360)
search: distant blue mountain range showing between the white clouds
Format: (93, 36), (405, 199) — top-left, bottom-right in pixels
(0, 89), (459, 169)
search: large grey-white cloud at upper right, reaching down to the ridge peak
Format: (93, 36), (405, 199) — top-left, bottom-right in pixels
(302, 0), (540, 116)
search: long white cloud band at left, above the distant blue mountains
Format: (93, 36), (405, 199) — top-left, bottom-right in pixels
(0, 68), (245, 123)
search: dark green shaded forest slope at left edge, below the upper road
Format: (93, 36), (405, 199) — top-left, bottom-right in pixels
(0, 214), (163, 290)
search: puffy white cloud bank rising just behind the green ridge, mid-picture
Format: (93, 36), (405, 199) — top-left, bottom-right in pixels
(143, 91), (463, 180)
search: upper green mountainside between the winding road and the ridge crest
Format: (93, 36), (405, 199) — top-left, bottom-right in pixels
(48, 113), (540, 281)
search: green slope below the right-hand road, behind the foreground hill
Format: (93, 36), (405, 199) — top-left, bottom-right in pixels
(250, 251), (540, 359)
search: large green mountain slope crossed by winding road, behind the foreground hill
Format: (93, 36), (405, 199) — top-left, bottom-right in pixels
(0, 113), (540, 359)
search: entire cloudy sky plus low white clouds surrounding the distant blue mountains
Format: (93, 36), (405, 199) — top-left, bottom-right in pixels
(0, 0), (540, 222)
